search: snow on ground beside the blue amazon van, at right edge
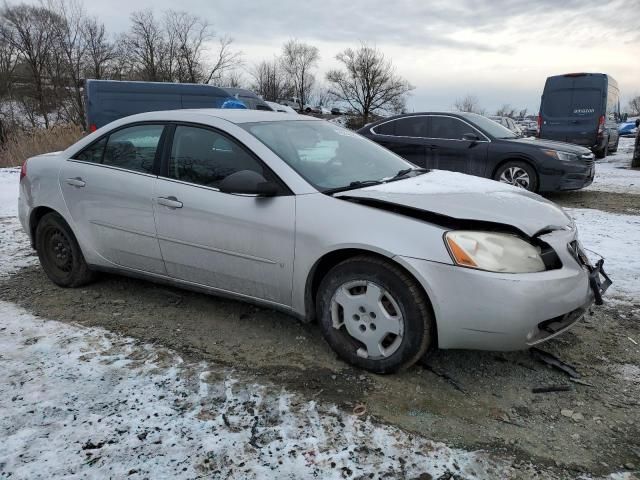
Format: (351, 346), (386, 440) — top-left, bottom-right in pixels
(585, 137), (640, 195)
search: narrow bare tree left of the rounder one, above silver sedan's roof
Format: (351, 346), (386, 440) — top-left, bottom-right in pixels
(280, 39), (320, 111)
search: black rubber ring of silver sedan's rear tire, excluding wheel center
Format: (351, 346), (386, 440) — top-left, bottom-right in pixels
(36, 213), (87, 287)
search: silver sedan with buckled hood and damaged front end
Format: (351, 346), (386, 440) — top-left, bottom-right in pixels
(19, 110), (609, 373)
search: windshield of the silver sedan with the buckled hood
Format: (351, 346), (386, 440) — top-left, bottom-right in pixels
(241, 120), (416, 192)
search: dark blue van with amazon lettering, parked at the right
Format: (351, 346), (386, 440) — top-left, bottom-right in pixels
(538, 73), (621, 158)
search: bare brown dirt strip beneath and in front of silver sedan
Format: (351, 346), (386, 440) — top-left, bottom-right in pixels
(0, 215), (640, 478)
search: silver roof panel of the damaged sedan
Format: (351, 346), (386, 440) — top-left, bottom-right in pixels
(124, 108), (322, 124)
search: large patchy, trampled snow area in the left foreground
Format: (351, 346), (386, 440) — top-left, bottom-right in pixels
(0, 302), (519, 479)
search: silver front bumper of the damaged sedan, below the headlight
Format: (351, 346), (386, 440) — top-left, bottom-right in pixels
(398, 227), (606, 351)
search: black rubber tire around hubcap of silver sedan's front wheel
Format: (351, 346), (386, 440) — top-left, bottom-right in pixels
(316, 260), (434, 373)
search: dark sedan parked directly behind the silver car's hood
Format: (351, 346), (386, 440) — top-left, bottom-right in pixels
(358, 112), (595, 192)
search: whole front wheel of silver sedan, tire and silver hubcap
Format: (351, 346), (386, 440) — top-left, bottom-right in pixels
(316, 256), (435, 373)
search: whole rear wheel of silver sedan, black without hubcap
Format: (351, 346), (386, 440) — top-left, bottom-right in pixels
(36, 212), (95, 288)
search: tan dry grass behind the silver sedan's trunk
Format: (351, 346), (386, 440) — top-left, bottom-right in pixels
(0, 125), (84, 167)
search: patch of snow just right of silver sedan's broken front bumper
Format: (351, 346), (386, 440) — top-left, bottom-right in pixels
(564, 208), (640, 301)
